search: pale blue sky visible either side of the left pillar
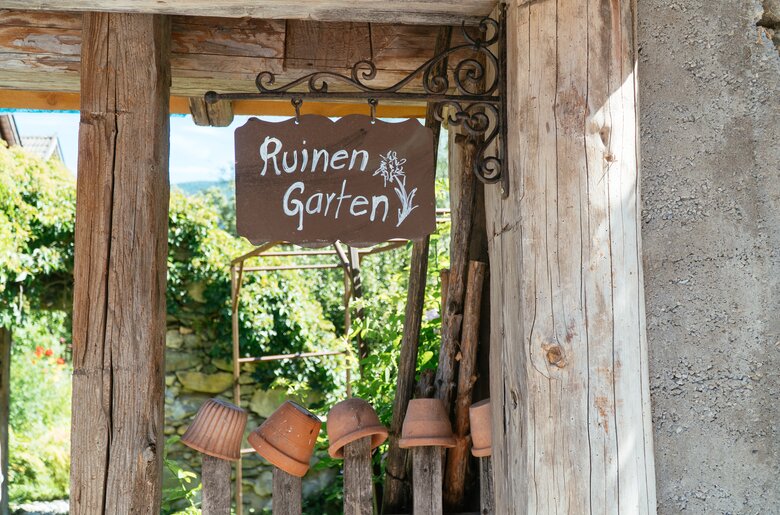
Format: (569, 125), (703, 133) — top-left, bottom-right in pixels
(13, 112), (256, 184)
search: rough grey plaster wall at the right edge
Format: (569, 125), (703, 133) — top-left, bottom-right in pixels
(638, 0), (780, 514)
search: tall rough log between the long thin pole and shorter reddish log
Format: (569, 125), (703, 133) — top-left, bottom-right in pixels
(436, 129), (477, 413)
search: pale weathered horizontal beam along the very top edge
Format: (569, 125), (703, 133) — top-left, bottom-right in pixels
(0, 0), (496, 25)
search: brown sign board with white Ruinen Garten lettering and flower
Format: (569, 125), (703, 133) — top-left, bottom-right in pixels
(235, 115), (436, 245)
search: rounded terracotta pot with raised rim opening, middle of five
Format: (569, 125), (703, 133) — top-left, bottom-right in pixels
(328, 397), (387, 458)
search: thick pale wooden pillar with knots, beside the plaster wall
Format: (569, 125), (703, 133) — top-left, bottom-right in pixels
(487, 0), (655, 514)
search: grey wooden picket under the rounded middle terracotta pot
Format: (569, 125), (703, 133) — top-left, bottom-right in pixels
(344, 436), (374, 515)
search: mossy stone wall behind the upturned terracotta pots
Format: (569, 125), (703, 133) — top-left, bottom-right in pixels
(163, 318), (336, 513)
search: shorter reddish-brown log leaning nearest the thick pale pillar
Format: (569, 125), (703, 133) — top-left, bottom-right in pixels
(444, 261), (487, 511)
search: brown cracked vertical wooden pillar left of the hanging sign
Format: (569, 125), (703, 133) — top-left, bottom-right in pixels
(70, 13), (170, 515)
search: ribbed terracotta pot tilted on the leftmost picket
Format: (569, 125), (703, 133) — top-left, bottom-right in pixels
(181, 399), (247, 461)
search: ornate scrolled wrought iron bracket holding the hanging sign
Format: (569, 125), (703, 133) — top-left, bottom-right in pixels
(206, 4), (509, 197)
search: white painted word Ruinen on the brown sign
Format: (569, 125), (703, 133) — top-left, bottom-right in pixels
(260, 136), (368, 176)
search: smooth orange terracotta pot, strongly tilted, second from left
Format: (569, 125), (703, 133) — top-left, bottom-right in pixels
(248, 401), (322, 477)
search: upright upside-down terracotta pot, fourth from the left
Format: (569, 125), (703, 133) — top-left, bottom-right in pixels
(398, 399), (455, 449)
